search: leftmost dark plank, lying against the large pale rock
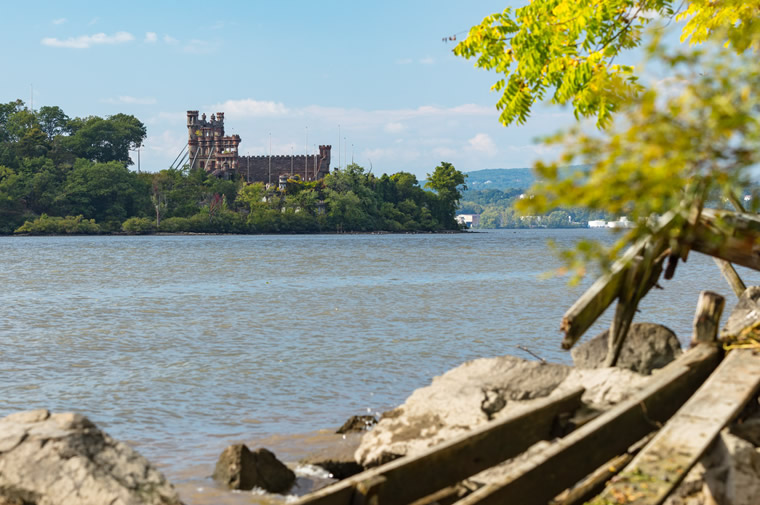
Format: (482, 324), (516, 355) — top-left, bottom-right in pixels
(296, 388), (583, 505)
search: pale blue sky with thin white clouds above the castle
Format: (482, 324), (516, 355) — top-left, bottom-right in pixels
(0, 0), (572, 179)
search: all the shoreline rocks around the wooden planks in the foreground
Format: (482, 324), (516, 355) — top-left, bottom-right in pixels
(0, 323), (760, 505)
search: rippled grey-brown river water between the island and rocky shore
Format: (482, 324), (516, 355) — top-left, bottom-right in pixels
(0, 230), (757, 503)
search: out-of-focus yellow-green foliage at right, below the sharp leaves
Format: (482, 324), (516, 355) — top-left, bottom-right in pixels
(519, 35), (760, 264)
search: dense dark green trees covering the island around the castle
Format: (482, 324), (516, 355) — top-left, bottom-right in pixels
(0, 100), (466, 234)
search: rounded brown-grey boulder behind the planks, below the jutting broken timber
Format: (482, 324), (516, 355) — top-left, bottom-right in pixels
(571, 323), (681, 374)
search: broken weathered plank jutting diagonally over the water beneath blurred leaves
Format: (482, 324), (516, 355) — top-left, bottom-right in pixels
(560, 212), (683, 349)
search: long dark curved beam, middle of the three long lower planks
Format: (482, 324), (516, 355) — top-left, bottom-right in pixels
(448, 345), (720, 505)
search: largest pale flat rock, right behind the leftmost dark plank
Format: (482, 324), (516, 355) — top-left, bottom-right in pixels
(355, 356), (647, 467)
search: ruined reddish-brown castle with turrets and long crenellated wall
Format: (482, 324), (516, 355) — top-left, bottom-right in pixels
(187, 110), (331, 184)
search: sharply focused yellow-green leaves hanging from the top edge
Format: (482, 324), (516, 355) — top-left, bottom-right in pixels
(454, 0), (760, 126)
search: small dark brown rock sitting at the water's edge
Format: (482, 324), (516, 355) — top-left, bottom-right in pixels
(212, 444), (296, 493)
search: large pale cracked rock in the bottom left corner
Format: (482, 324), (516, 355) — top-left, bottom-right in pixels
(0, 410), (181, 505)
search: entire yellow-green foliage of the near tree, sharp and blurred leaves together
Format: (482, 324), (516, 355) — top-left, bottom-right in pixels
(455, 0), (760, 271)
